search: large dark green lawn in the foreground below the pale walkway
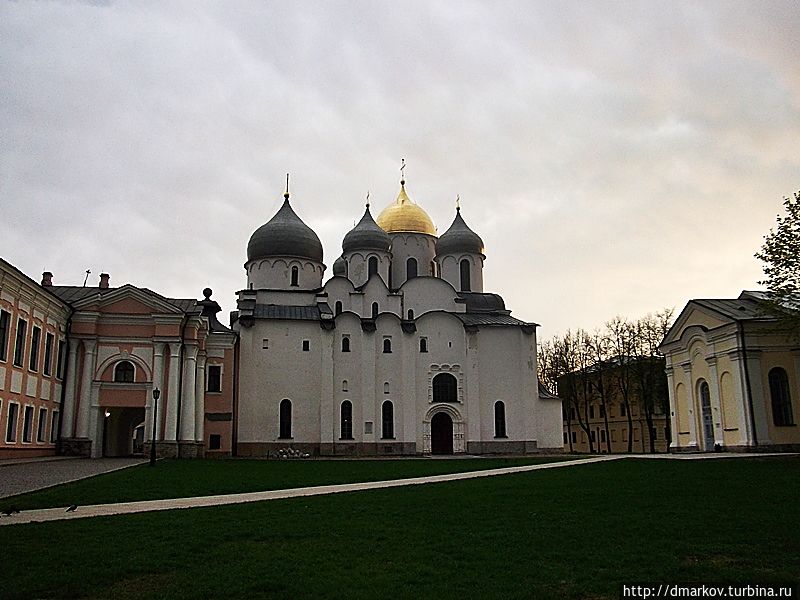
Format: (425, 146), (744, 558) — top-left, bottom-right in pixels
(0, 458), (800, 600)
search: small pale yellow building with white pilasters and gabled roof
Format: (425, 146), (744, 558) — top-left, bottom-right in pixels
(660, 291), (800, 452)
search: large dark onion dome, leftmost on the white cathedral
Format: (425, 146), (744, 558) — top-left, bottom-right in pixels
(247, 195), (322, 263)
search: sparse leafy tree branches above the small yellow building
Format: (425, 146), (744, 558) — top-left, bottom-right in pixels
(755, 191), (800, 337)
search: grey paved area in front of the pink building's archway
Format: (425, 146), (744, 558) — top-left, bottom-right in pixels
(0, 457), (147, 498)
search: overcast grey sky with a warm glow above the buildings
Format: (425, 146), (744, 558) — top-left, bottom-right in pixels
(0, 0), (800, 340)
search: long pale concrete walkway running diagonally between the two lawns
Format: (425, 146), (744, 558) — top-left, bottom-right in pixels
(0, 453), (791, 525)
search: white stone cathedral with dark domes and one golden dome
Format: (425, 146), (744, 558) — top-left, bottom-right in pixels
(233, 181), (562, 456)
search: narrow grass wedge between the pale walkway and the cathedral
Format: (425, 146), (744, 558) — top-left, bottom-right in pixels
(0, 456), (575, 510)
